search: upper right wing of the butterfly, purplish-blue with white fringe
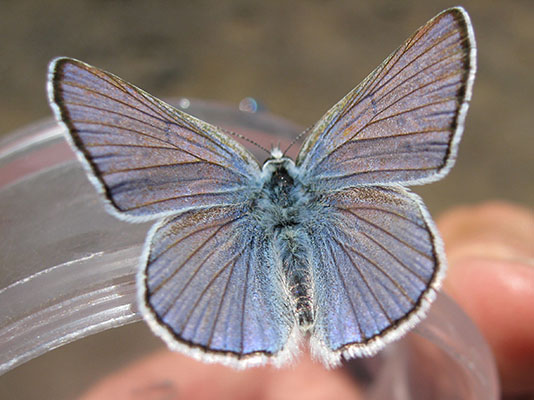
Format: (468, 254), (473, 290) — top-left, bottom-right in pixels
(297, 8), (475, 190)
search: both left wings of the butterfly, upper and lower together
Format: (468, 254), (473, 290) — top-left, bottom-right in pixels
(49, 58), (296, 367)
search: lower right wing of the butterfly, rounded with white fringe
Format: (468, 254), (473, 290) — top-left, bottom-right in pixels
(310, 185), (446, 364)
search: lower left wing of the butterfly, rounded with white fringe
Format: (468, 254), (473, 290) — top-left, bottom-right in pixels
(137, 206), (296, 367)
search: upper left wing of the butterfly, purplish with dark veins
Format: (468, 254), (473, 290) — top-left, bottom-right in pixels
(48, 58), (260, 221)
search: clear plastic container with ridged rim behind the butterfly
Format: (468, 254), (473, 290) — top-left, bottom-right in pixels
(0, 99), (499, 400)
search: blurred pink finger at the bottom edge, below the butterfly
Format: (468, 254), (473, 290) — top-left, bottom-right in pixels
(81, 351), (361, 400)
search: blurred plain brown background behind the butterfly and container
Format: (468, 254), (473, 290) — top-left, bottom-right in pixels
(0, 0), (534, 400)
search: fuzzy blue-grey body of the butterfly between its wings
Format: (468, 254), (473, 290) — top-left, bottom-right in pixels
(253, 157), (314, 330)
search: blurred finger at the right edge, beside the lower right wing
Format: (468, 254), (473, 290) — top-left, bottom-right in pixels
(438, 203), (534, 394)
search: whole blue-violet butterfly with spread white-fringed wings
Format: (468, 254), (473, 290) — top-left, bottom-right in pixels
(48, 7), (476, 368)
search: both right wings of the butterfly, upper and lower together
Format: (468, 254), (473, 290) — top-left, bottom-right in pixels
(297, 8), (475, 364)
